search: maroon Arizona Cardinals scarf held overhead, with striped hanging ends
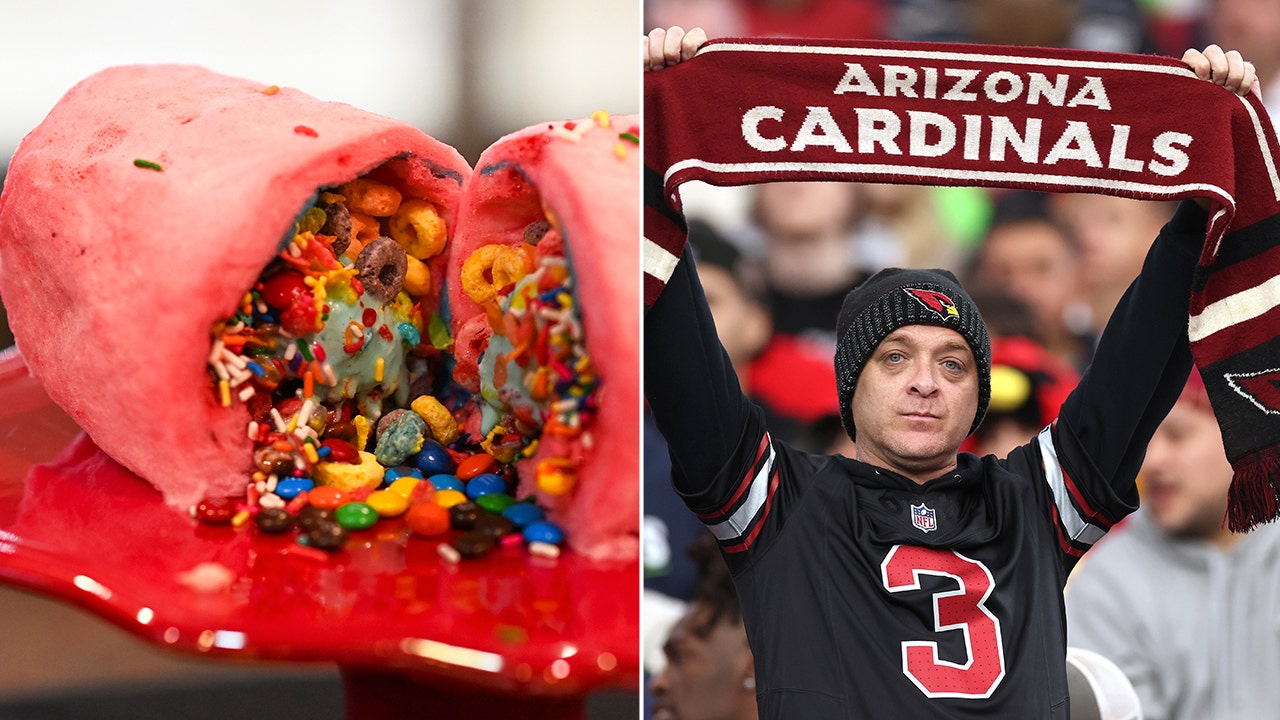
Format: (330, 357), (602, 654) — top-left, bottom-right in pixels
(644, 40), (1280, 530)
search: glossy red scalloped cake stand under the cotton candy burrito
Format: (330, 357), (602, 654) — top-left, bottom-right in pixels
(0, 350), (640, 719)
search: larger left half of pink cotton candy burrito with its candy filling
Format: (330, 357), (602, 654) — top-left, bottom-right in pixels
(0, 65), (470, 509)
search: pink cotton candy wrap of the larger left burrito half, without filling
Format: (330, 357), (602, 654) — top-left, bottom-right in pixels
(0, 65), (470, 507)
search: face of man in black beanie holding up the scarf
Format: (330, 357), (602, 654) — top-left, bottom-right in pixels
(851, 325), (978, 482)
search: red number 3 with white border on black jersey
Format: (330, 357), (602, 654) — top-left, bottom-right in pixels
(881, 544), (1005, 698)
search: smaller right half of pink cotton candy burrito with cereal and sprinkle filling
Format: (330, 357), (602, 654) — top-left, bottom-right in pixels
(448, 111), (641, 557)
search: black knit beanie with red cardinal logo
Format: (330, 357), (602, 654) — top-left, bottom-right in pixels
(836, 268), (991, 442)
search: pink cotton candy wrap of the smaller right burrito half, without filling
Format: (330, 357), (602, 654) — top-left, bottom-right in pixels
(449, 115), (641, 557)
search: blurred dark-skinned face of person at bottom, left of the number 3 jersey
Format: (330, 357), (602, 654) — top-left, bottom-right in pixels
(649, 605), (755, 720)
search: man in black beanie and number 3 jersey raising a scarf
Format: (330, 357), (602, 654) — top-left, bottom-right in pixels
(644, 28), (1254, 720)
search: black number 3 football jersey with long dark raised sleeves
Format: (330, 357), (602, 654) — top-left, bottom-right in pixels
(645, 198), (1204, 720)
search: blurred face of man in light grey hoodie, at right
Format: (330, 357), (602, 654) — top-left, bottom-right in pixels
(1142, 401), (1231, 539)
